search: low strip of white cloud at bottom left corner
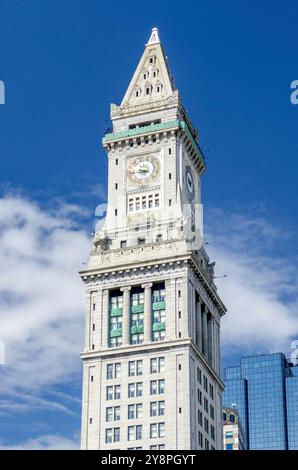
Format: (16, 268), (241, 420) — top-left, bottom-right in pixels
(0, 434), (79, 450)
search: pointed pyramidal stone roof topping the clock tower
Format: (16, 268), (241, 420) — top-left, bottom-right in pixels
(121, 28), (176, 106)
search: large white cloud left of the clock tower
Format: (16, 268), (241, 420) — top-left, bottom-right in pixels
(0, 195), (90, 396)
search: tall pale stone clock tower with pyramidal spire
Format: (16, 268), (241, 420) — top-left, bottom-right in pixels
(80, 28), (225, 450)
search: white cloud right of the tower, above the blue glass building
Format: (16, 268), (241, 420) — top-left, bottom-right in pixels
(208, 211), (298, 356)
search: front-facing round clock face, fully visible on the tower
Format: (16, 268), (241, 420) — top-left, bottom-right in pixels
(127, 155), (160, 185)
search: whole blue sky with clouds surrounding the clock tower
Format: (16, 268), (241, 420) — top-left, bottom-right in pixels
(0, 0), (298, 448)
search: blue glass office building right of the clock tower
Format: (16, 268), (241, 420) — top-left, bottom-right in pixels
(223, 353), (298, 450)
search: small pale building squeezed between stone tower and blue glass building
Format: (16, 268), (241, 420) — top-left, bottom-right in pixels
(222, 407), (247, 450)
